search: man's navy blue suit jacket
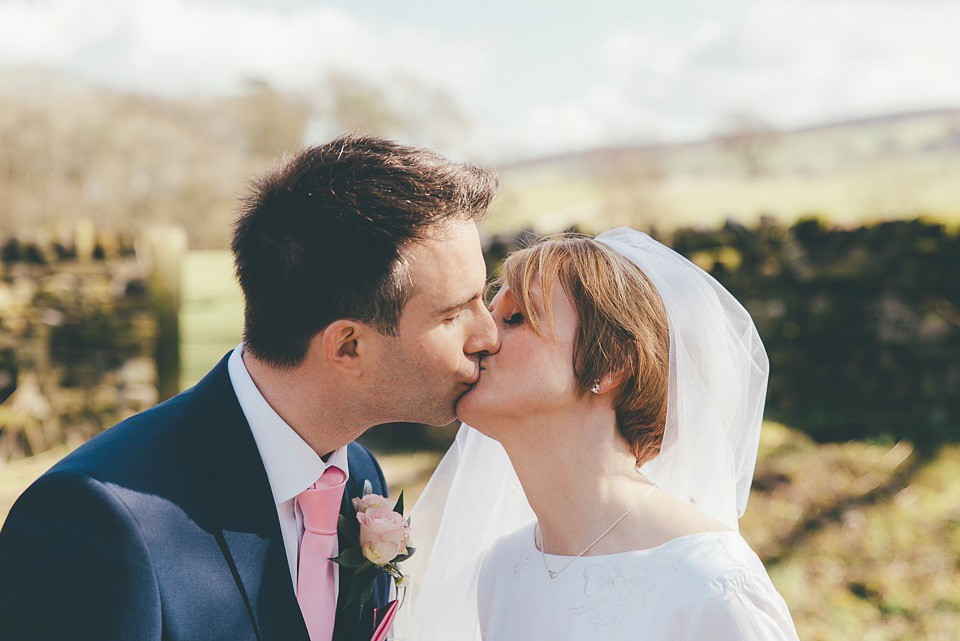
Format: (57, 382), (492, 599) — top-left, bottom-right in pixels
(0, 354), (390, 641)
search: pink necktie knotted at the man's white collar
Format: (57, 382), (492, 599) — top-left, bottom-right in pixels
(297, 466), (347, 641)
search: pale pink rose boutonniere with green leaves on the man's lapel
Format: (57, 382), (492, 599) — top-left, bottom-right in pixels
(330, 480), (414, 609)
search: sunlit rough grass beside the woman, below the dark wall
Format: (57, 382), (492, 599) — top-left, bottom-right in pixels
(741, 424), (960, 641)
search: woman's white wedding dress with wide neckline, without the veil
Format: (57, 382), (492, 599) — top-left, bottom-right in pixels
(477, 524), (797, 641)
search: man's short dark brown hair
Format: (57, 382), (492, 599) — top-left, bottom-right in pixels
(231, 135), (497, 367)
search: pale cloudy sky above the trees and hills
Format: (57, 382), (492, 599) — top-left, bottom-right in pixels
(0, 0), (960, 158)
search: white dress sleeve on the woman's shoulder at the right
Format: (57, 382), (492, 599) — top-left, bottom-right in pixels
(686, 568), (799, 641)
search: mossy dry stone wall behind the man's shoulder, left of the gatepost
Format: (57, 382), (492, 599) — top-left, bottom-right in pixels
(0, 222), (185, 461)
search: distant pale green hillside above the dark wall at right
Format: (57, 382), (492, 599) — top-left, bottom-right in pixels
(488, 110), (960, 232)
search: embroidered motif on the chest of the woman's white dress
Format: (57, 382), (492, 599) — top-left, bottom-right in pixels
(571, 559), (674, 635)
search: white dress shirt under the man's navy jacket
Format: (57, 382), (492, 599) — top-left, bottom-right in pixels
(227, 343), (350, 594)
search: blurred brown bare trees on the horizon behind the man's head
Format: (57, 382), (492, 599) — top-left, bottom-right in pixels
(0, 73), (467, 247)
